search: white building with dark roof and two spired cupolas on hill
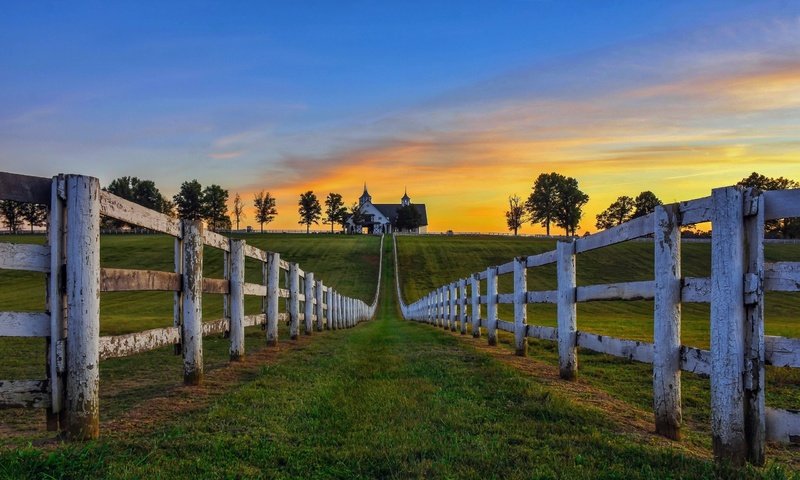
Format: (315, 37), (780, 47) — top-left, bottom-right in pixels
(346, 183), (428, 234)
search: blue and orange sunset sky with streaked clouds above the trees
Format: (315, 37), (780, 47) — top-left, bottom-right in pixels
(0, 0), (800, 234)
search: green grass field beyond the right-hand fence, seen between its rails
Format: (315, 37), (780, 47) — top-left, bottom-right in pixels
(398, 236), (800, 454)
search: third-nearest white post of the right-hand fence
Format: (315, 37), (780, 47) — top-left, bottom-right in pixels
(556, 241), (578, 380)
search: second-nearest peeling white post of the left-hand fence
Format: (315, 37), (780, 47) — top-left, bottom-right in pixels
(181, 220), (203, 385)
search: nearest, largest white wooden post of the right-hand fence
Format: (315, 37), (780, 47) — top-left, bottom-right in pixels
(711, 187), (747, 465)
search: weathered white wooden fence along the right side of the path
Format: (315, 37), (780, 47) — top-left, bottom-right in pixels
(395, 187), (800, 465)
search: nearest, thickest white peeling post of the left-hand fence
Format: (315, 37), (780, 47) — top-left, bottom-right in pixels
(66, 175), (100, 440)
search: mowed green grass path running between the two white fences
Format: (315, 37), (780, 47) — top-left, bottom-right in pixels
(0, 238), (787, 479)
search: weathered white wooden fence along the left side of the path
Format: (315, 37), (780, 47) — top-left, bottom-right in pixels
(0, 172), (383, 439)
